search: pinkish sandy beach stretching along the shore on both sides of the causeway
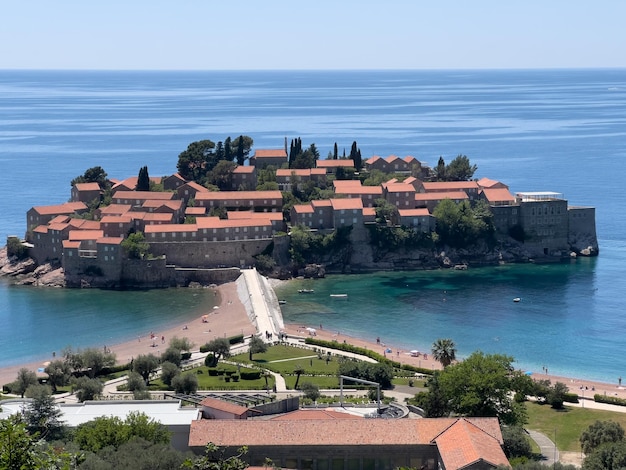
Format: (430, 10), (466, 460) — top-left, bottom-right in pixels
(0, 276), (626, 404)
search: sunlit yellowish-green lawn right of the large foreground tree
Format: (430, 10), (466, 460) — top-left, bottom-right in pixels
(526, 402), (626, 452)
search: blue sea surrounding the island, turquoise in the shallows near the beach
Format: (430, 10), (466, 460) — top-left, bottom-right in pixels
(0, 69), (626, 383)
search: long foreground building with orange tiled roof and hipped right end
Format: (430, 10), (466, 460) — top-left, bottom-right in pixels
(189, 411), (509, 470)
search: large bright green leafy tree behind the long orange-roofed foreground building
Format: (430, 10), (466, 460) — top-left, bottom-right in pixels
(439, 351), (530, 425)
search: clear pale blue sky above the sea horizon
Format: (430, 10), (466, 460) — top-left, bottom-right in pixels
(0, 0), (626, 70)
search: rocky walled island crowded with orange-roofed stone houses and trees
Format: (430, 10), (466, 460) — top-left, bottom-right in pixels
(2, 136), (599, 289)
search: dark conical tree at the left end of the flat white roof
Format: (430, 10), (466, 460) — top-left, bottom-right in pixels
(24, 385), (64, 441)
